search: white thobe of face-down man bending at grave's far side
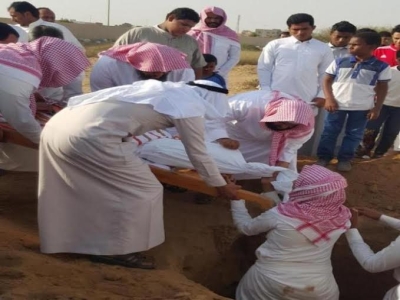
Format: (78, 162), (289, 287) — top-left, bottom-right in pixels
(227, 90), (312, 170)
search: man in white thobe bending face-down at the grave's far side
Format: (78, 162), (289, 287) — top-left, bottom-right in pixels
(227, 90), (314, 170)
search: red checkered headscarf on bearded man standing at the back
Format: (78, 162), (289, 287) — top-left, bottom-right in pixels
(188, 6), (239, 53)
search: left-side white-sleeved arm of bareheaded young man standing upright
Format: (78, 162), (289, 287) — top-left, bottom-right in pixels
(257, 42), (276, 90)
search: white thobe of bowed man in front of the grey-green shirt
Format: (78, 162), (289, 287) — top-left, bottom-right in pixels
(90, 55), (195, 92)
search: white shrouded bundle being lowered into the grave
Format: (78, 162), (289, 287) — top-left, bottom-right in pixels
(139, 138), (298, 193)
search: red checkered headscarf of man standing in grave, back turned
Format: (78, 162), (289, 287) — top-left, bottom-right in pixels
(277, 165), (351, 245)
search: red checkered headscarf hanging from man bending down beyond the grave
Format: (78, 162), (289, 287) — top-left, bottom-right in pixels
(260, 91), (315, 166)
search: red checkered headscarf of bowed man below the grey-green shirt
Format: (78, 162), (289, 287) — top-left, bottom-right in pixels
(99, 42), (190, 73)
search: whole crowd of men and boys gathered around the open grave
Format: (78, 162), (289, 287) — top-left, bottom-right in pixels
(0, 1), (400, 300)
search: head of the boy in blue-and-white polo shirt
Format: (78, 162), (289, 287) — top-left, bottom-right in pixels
(349, 29), (381, 58)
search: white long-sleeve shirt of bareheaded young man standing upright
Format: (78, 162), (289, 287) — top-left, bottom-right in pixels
(257, 36), (334, 102)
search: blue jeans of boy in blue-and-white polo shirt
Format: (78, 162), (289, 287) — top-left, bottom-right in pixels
(317, 110), (368, 161)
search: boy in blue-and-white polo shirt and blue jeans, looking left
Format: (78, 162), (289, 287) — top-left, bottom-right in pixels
(317, 30), (391, 172)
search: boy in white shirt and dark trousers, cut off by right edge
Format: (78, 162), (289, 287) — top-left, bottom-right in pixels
(357, 50), (400, 158)
